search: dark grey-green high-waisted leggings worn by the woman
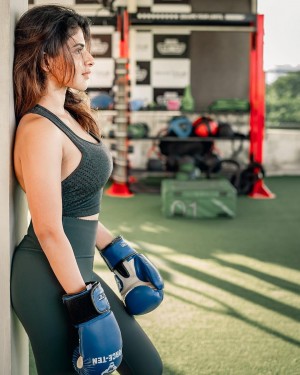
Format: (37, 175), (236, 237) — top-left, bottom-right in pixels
(11, 217), (162, 375)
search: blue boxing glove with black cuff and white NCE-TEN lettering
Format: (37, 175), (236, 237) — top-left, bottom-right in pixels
(63, 282), (122, 375)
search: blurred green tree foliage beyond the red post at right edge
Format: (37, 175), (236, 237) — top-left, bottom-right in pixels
(266, 72), (300, 126)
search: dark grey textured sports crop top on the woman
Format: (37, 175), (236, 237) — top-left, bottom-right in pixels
(29, 104), (112, 217)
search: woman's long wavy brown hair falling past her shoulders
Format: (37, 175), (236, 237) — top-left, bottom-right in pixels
(13, 5), (99, 136)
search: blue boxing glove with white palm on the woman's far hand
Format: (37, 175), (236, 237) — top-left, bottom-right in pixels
(100, 236), (164, 315)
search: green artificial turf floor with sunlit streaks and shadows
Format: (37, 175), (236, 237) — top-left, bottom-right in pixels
(31, 177), (300, 375)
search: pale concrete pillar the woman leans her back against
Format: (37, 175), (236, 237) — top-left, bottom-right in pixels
(0, 0), (29, 375)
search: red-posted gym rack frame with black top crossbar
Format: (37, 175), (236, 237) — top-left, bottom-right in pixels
(91, 2), (274, 198)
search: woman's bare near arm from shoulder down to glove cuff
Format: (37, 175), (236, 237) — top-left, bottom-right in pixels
(15, 118), (85, 293)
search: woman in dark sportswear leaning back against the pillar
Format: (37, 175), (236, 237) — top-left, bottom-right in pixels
(11, 5), (162, 375)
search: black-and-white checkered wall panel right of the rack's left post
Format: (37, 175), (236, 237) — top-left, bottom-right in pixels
(131, 31), (191, 105)
